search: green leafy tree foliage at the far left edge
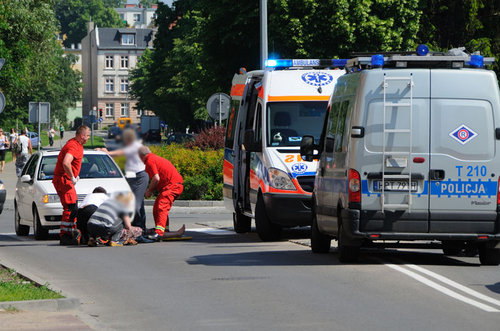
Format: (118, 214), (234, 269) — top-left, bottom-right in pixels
(0, 0), (81, 128)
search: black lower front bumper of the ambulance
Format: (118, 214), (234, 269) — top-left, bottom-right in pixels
(262, 193), (312, 227)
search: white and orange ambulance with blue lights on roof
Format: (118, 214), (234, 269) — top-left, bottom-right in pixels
(223, 59), (346, 241)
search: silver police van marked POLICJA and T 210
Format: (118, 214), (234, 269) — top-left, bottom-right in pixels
(301, 45), (500, 265)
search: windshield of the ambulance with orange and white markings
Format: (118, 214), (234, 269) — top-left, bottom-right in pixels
(267, 101), (327, 146)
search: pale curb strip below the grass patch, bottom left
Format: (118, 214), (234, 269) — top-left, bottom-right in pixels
(0, 298), (80, 312)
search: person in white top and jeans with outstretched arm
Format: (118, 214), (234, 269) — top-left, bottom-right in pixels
(96, 129), (149, 230)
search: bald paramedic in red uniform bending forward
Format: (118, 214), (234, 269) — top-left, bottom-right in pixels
(139, 146), (183, 241)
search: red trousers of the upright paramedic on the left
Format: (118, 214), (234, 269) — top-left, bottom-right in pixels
(52, 177), (78, 236)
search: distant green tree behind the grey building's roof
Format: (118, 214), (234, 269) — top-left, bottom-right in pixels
(55, 0), (125, 47)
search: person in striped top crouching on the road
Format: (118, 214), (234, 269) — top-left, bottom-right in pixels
(87, 193), (142, 246)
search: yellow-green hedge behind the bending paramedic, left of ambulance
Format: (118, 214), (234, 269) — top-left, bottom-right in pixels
(115, 144), (224, 200)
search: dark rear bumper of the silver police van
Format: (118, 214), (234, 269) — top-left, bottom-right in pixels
(341, 209), (500, 241)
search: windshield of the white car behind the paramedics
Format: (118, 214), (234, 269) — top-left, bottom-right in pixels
(38, 154), (122, 180)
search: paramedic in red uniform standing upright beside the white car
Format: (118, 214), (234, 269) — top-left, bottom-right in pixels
(52, 125), (90, 245)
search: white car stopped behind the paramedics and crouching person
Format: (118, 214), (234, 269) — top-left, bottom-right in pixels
(14, 150), (135, 240)
